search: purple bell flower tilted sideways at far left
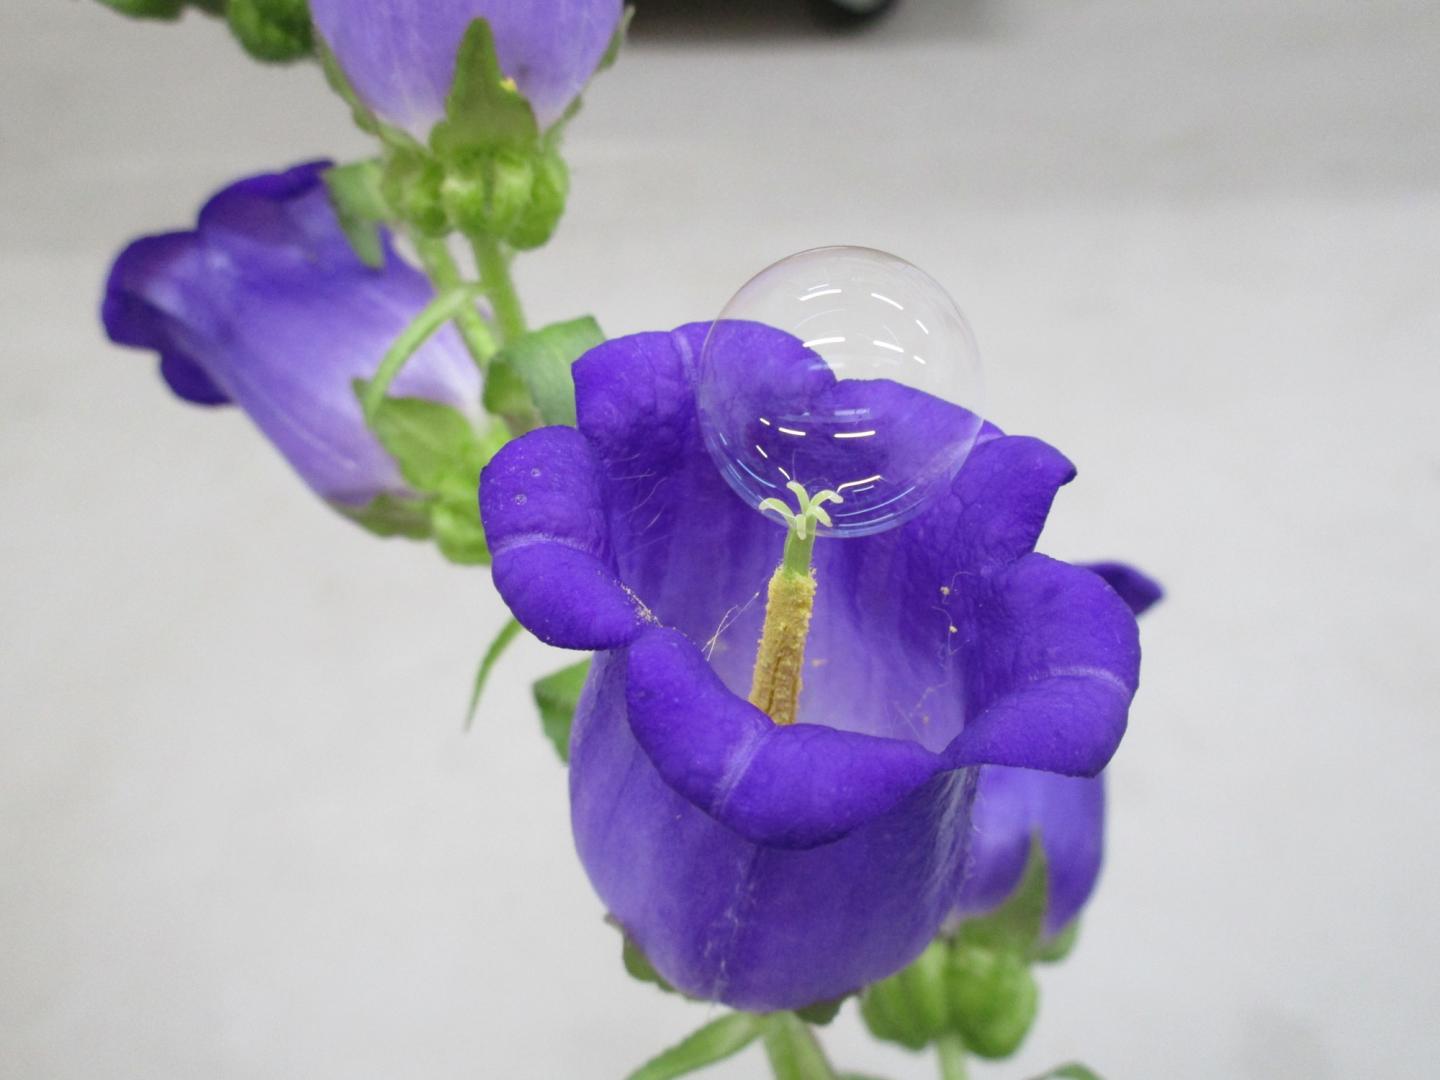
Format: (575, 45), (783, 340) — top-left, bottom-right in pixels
(101, 161), (480, 510)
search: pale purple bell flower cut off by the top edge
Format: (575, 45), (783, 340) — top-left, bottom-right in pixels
(310, 0), (622, 141)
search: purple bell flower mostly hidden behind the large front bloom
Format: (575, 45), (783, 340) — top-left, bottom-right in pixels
(956, 563), (1162, 939)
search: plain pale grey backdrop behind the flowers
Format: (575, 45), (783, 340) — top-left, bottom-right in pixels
(0, 0), (1440, 1080)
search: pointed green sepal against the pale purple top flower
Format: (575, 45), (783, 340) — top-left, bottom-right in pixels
(431, 19), (540, 160)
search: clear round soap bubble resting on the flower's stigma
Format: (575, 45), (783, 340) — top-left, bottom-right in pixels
(698, 246), (982, 536)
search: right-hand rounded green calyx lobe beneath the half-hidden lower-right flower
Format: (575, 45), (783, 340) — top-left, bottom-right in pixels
(946, 942), (1040, 1058)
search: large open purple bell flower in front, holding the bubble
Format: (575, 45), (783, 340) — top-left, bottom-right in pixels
(481, 324), (1139, 1011)
